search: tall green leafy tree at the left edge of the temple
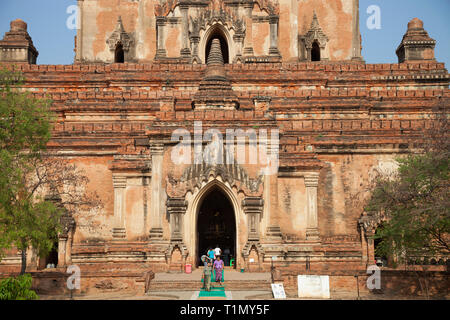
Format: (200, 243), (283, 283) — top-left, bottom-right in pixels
(0, 70), (61, 273)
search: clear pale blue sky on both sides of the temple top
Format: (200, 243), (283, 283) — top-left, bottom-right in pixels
(0, 0), (450, 68)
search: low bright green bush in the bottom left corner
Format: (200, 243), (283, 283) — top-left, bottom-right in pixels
(0, 274), (39, 300)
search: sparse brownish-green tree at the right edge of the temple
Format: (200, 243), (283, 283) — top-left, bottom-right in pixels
(366, 108), (450, 263)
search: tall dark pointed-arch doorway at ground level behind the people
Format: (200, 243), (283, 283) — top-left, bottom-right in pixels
(197, 188), (236, 267)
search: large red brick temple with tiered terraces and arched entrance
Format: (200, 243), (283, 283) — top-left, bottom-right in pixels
(0, 0), (450, 296)
